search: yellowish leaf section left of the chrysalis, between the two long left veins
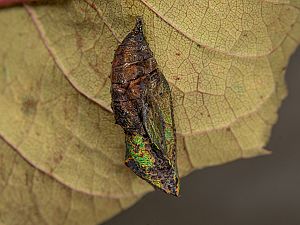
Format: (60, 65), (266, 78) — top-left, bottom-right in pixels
(0, 6), (149, 198)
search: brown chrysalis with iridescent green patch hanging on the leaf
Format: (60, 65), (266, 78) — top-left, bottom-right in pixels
(111, 18), (179, 196)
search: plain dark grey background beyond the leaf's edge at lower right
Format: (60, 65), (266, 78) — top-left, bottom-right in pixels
(104, 49), (300, 225)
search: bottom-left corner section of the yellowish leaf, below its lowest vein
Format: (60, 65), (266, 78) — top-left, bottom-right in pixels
(0, 139), (137, 225)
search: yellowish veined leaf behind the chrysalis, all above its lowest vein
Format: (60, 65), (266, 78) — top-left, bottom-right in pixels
(0, 0), (300, 224)
